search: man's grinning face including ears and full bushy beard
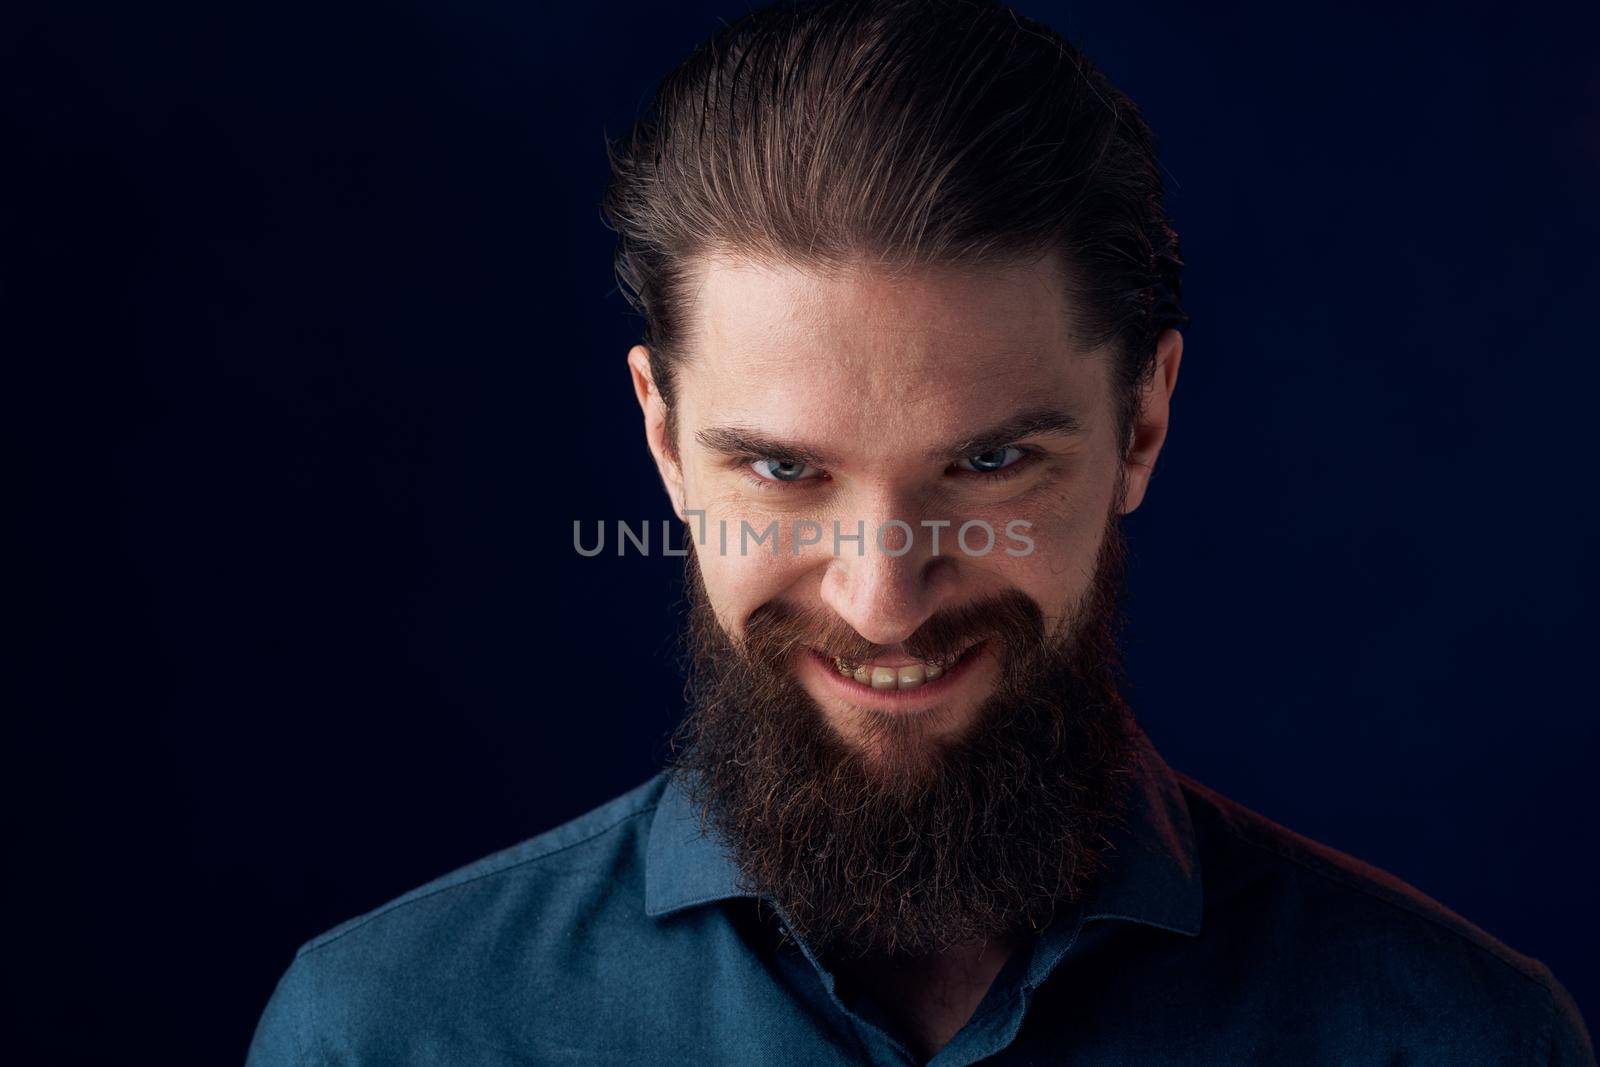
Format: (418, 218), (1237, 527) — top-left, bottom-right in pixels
(629, 259), (1179, 957)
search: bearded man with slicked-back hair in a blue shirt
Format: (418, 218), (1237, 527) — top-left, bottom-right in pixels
(251, 0), (1594, 1067)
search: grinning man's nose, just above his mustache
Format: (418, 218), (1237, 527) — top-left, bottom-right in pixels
(821, 517), (955, 646)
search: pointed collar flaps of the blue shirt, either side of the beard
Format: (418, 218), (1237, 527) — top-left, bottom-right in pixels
(645, 728), (1203, 936)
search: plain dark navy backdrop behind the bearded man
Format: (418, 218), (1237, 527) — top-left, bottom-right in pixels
(0, 0), (1600, 1064)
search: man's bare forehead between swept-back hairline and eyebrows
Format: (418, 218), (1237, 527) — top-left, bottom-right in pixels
(678, 258), (1107, 454)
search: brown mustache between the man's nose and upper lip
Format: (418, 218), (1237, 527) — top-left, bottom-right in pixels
(741, 590), (1048, 667)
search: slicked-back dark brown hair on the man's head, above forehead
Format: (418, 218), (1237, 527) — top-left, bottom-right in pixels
(603, 0), (1187, 440)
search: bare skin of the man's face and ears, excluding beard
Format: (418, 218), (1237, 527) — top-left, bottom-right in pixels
(629, 256), (1182, 745)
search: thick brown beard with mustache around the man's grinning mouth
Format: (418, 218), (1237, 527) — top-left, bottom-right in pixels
(674, 518), (1136, 958)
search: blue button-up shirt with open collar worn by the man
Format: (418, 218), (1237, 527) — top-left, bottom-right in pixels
(250, 739), (1595, 1067)
